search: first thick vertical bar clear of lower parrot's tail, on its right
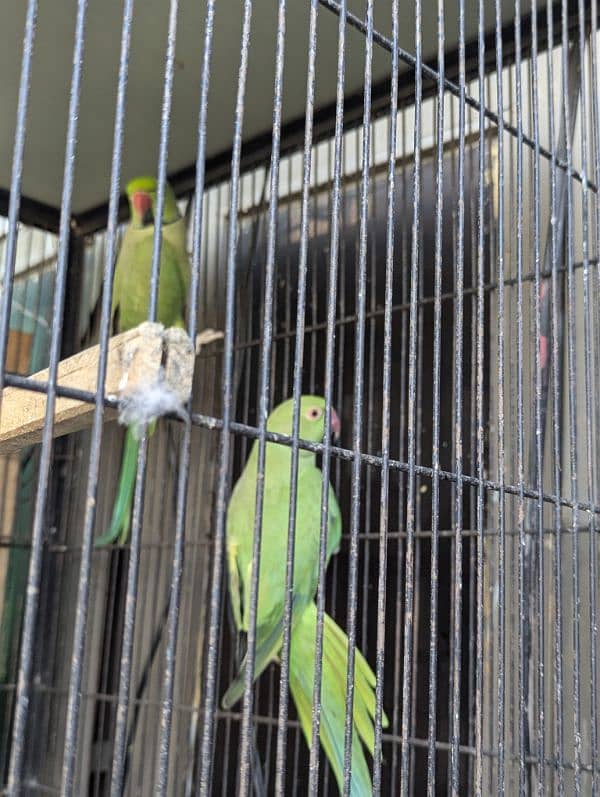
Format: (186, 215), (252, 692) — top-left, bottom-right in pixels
(400, 0), (423, 797)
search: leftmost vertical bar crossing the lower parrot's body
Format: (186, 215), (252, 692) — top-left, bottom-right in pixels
(239, 0), (286, 795)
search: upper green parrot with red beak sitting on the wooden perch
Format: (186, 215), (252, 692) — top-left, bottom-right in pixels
(96, 177), (190, 546)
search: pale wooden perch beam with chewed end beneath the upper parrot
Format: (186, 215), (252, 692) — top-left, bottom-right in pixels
(0, 322), (194, 454)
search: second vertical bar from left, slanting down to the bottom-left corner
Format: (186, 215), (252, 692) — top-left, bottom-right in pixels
(4, 0), (87, 797)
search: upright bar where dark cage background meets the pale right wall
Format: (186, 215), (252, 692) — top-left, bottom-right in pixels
(473, 0), (491, 797)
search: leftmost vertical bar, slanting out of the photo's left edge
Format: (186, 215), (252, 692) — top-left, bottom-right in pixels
(0, 0), (38, 412)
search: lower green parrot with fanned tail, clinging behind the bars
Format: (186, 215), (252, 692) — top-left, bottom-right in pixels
(222, 396), (387, 797)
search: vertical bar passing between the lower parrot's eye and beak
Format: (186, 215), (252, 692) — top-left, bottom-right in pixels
(308, 0), (346, 797)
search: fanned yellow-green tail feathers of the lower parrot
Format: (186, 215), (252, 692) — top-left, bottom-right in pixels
(290, 602), (388, 797)
